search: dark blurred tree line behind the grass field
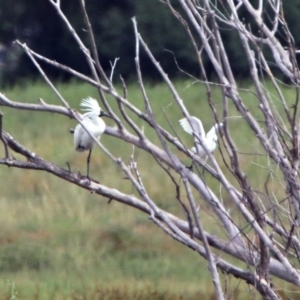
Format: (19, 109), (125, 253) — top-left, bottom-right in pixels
(0, 0), (300, 84)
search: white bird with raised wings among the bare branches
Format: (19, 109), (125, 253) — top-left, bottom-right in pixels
(179, 116), (223, 159)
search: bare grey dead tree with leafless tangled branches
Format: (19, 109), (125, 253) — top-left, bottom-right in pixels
(0, 0), (300, 299)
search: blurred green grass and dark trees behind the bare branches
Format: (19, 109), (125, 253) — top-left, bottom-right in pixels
(0, 0), (300, 300)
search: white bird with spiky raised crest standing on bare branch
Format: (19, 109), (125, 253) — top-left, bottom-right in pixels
(74, 97), (111, 178)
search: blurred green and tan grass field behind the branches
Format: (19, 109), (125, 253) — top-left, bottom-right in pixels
(0, 78), (294, 300)
